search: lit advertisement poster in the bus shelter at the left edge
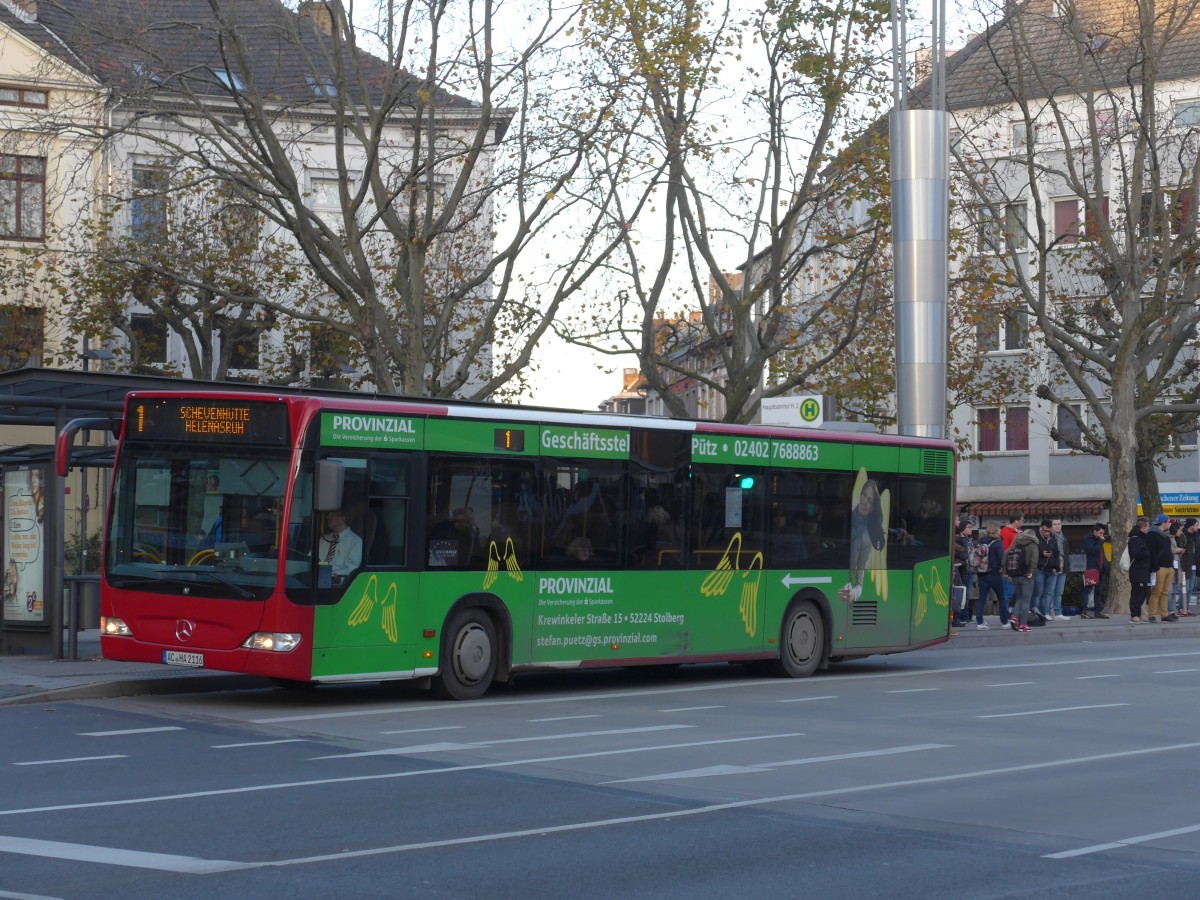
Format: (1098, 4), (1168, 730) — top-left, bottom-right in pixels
(4, 468), (46, 625)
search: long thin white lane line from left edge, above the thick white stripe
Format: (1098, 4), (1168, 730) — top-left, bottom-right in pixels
(0, 731), (806, 816)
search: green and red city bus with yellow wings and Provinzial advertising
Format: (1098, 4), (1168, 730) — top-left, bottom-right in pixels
(82, 390), (954, 700)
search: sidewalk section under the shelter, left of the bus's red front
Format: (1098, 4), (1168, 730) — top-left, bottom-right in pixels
(0, 629), (270, 706)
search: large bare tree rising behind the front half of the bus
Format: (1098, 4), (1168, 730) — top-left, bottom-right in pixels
(31, 0), (616, 397)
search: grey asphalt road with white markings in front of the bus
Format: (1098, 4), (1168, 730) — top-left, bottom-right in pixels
(0, 640), (1200, 900)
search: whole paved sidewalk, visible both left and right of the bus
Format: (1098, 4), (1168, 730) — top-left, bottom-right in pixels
(0, 616), (1200, 706)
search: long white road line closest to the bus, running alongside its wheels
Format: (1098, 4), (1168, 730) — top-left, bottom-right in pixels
(248, 650), (1200, 725)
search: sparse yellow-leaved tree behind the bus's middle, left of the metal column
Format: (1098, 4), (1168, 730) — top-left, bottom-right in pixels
(561, 0), (902, 421)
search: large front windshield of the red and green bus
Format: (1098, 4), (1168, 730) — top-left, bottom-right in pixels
(104, 444), (289, 600)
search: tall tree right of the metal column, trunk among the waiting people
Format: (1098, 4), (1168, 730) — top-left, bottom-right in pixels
(948, 0), (1200, 602)
